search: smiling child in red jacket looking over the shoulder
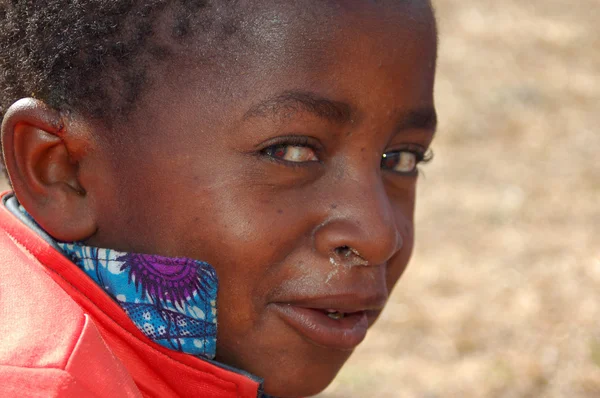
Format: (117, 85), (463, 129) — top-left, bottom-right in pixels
(0, 0), (437, 397)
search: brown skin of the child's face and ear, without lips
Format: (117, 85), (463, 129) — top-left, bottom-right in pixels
(2, 1), (437, 396)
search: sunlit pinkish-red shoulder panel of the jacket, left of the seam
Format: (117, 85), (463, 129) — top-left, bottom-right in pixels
(0, 230), (85, 368)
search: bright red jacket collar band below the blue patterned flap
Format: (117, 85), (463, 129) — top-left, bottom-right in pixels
(0, 192), (267, 398)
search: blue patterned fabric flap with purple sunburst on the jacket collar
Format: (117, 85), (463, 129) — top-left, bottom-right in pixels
(57, 242), (218, 359)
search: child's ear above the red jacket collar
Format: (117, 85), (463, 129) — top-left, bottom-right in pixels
(2, 98), (96, 242)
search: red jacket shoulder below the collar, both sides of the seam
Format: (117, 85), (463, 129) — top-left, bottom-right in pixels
(0, 229), (139, 397)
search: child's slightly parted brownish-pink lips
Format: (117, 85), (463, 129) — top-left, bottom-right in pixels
(270, 298), (383, 351)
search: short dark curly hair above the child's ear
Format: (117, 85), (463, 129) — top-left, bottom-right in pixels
(0, 0), (236, 123)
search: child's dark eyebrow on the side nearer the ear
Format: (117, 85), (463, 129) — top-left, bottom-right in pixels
(244, 91), (352, 124)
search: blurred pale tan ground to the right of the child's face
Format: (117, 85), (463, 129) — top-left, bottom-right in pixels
(320, 0), (600, 398)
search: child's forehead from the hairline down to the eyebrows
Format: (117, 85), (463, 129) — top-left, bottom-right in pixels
(131, 0), (437, 134)
